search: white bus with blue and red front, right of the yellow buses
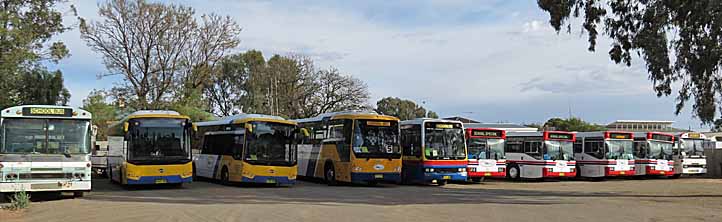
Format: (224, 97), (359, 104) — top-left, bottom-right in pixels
(401, 118), (469, 185)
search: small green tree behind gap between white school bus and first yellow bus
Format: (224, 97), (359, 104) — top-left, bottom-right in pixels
(81, 90), (120, 141)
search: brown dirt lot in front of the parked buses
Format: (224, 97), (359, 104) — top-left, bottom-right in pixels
(0, 178), (722, 222)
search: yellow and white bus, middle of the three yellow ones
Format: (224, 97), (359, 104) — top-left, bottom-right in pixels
(193, 114), (298, 185)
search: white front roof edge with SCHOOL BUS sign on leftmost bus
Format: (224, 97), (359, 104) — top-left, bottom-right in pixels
(0, 105), (92, 119)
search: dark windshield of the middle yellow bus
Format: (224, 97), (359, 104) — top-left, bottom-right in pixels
(243, 122), (297, 166)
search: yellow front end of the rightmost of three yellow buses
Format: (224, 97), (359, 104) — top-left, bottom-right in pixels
(350, 119), (401, 184)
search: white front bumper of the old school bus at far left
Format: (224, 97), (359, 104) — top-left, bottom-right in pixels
(0, 180), (91, 192)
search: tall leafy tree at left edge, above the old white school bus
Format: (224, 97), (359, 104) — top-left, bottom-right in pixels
(0, 0), (75, 108)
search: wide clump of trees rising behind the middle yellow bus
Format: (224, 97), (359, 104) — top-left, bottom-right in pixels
(205, 50), (369, 119)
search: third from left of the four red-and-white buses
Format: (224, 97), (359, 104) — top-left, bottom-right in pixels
(574, 131), (634, 178)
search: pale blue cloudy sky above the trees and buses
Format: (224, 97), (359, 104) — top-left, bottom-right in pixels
(56, 0), (700, 129)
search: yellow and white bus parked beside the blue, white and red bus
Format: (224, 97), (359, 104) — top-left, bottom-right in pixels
(296, 111), (401, 185)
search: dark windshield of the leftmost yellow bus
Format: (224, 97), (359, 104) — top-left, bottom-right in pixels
(128, 118), (190, 161)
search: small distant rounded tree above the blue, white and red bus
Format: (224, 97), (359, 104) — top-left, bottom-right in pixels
(376, 97), (439, 120)
